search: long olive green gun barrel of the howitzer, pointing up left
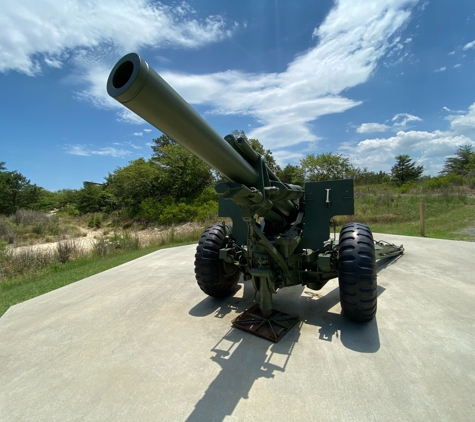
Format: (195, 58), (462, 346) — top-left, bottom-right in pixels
(107, 53), (258, 186)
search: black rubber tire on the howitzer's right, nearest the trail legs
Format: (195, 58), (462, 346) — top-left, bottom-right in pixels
(338, 223), (378, 322)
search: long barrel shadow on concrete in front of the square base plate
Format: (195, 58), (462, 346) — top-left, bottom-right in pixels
(186, 323), (302, 422)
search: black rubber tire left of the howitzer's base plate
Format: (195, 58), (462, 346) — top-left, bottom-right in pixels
(195, 224), (241, 298)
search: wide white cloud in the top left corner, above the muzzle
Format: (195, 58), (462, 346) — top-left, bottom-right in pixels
(0, 0), (232, 75)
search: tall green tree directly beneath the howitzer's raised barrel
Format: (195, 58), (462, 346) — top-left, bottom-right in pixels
(151, 135), (213, 200)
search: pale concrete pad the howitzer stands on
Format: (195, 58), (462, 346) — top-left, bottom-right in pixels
(0, 235), (475, 422)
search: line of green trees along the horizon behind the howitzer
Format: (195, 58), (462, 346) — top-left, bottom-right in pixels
(0, 135), (475, 224)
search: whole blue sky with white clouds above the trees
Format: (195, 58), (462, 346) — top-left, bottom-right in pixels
(0, 0), (475, 190)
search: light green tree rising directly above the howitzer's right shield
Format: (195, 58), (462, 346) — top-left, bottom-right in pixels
(300, 152), (354, 182)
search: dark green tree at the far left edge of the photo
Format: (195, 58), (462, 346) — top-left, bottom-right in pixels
(0, 162), (40, 214)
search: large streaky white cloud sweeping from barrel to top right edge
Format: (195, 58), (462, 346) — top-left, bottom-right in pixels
(142, 0), (420, 150)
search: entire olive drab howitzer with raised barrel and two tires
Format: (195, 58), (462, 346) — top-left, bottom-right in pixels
(107, 53), (404, 341)
